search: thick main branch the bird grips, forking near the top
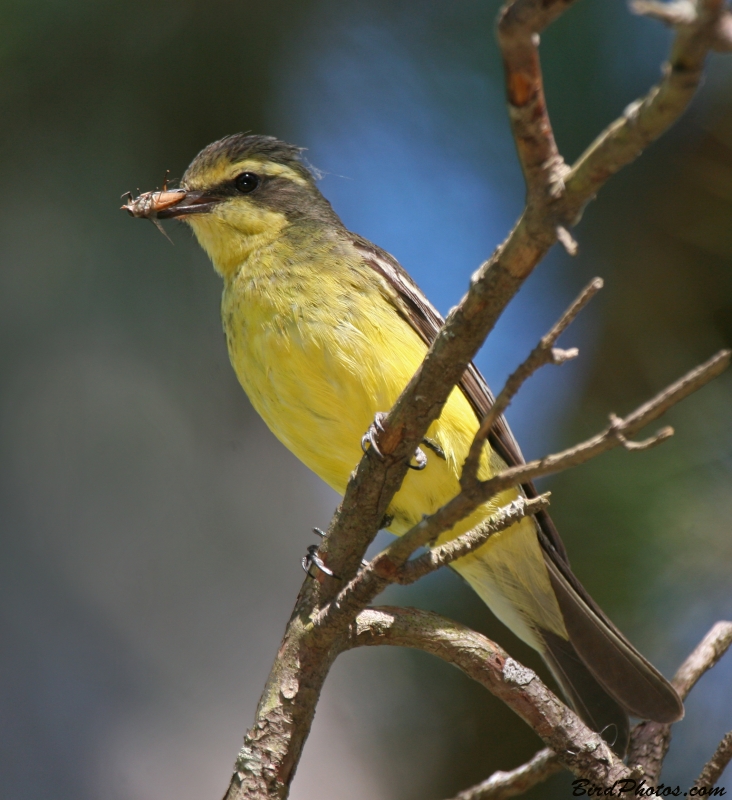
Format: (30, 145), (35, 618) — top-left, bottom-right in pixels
(226, 0), (722, 800)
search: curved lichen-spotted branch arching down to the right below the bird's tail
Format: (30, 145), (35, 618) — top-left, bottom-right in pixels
(348, 606), (631, 786)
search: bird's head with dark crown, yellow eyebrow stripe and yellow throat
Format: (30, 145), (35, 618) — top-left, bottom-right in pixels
(144, 134), (341, 276)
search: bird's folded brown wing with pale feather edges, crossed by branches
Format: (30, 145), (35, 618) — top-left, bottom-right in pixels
(351, 234), (569, 566)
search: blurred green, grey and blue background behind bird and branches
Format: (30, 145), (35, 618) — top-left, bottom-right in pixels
(0, 0), (732, 800)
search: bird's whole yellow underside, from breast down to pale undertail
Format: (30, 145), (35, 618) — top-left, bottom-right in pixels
(222, 253), (566, 646)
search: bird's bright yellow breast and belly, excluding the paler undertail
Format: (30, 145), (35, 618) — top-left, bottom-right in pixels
(222, 233), (508, 533)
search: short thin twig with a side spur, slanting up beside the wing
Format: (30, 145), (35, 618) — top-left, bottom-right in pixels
(460, 278), (603, 488)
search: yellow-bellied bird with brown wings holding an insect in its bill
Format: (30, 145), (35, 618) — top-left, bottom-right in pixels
(123, 133), (684, 754)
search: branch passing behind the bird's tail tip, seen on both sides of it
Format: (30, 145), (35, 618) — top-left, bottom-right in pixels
(628, 622), (732, 784)
